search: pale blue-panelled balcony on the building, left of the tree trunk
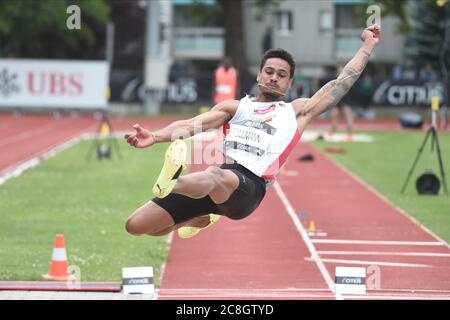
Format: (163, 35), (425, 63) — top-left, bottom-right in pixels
(173, 28), (225, 60)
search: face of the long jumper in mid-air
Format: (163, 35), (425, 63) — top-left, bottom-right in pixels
(256, 58), (292, 99)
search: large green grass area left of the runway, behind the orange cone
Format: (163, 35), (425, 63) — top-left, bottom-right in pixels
(0, 141), (172, 285)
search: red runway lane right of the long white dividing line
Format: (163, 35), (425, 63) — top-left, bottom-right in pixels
(274, 143), (450, 298)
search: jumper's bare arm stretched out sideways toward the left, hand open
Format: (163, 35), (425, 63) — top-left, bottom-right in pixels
(121, 100), (239, 148)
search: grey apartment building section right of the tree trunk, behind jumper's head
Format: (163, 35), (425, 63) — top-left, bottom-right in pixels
(244, 0), (404, 77)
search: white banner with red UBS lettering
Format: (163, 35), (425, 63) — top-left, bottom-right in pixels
(0, 59), (109, 109)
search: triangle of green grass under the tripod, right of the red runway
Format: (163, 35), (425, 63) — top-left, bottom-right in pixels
(315, 132), (450, 243)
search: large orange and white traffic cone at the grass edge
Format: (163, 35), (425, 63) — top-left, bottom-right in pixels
(42, 234), (76, 281)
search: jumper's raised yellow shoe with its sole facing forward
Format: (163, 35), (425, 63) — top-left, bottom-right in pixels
(153, 139), (187, 198)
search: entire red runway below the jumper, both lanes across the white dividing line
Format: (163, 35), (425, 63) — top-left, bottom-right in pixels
(158, 132), (450, 299)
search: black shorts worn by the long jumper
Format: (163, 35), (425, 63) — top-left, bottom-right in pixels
(153, 164), (266, 224)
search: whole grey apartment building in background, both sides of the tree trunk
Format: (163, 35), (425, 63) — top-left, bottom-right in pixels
(172, 0), (404, 77)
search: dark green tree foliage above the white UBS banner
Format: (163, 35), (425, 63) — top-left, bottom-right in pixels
(0, 0), (110, 59)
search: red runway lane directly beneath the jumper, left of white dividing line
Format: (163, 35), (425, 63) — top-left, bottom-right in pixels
(158, 137), (334, 300)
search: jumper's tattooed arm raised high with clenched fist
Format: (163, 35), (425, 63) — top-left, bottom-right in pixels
(292, 25), (381, 132)
